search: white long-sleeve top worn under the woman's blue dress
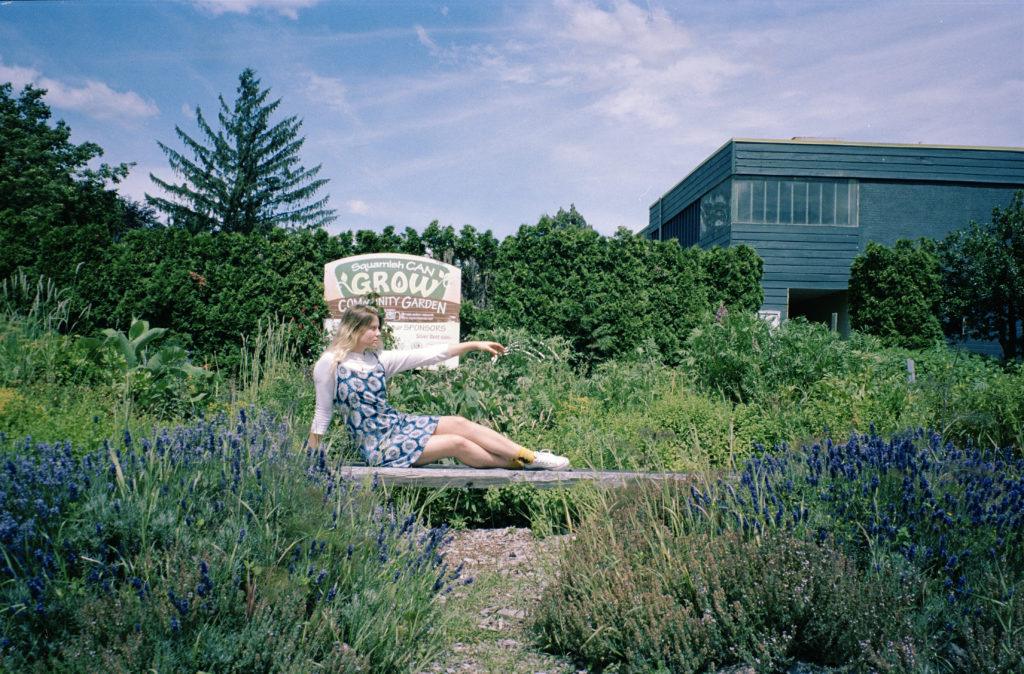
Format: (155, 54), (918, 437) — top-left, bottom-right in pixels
(309, 346), (452, 435)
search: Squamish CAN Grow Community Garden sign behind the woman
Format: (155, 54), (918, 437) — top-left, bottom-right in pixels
(324, 253), (462, 368)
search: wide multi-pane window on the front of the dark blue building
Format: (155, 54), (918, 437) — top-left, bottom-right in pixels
(732, 178), (857, 225)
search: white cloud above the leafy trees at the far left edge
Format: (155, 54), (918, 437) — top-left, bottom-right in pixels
(0, 58), (160, 122)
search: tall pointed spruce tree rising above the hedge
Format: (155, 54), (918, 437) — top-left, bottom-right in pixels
(146, 69), (336, 235)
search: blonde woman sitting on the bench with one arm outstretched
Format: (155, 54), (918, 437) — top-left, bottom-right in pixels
(309, 306), (569, 470)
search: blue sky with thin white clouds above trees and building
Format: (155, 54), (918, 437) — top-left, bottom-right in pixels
(0, 0), (1024, 239)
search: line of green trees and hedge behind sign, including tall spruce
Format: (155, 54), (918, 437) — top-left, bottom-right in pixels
(0, 70), (763, 367)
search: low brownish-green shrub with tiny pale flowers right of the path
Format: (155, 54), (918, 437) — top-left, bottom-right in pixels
(534, 490), (920, 672)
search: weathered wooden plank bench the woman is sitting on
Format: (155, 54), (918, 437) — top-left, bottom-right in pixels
(335, 465), (687, 489)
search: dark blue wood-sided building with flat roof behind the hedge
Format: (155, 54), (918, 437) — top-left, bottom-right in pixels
(643, 138), (1024, 333)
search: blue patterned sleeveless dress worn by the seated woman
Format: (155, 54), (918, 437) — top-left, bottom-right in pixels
(334, 360), (440, 468)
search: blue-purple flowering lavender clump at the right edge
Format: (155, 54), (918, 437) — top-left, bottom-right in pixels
(692, 431), (1024, 671)
